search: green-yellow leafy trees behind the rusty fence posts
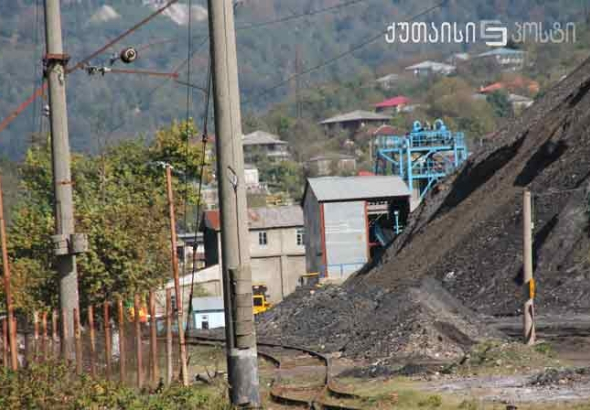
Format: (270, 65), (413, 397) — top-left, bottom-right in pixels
(1, 123), (203, 310)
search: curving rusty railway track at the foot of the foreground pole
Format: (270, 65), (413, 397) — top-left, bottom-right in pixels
(187, 336), (364, 410)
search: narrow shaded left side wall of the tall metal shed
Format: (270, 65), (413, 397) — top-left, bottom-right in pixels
(303, 189), (323, 273)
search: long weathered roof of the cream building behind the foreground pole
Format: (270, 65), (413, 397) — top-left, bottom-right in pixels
(203, 206), (303, 231)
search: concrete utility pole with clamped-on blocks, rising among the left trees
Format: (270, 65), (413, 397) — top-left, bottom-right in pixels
(44, 0), (87, 358)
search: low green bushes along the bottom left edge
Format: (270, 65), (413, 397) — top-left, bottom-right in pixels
(0, 362), (229, 410)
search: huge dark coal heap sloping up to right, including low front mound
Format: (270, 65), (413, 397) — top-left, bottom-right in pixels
(259, 56), (590, 358)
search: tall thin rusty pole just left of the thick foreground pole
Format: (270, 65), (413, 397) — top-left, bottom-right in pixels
(166, 165), (188, 386)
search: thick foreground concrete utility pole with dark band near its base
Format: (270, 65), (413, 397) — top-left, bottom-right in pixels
(208, 0), (260, 408)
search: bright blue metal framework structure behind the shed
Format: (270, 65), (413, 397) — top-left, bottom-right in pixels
(374, 120), (468, 200)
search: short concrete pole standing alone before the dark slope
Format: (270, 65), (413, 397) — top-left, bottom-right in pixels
(522, 189), (535, 345)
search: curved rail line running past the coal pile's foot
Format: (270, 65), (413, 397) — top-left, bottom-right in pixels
(186, 336), (363, 410)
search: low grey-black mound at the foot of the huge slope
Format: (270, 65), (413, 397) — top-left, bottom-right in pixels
(258, 278), (501, 360)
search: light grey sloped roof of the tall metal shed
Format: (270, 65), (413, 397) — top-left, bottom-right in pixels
(306, 175), (410, 202)
